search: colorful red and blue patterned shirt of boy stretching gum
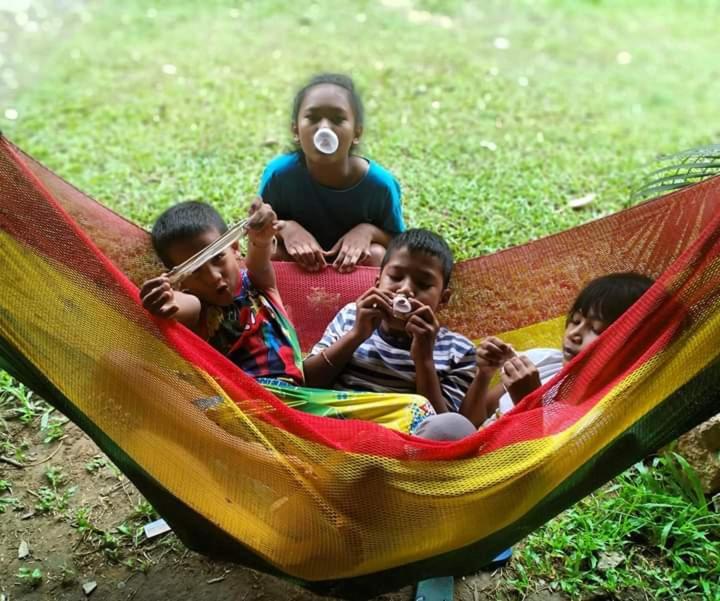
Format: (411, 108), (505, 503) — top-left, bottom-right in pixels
(200, 270), (304, 385)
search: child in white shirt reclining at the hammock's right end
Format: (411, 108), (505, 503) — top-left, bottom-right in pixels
(417, 272), (653, 439)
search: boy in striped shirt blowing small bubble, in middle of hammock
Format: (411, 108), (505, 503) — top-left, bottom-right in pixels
(304, 229), (486, 420)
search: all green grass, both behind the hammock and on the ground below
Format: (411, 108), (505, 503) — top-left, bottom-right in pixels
(0, 0), (720, 599)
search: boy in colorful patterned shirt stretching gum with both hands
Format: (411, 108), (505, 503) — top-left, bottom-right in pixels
(140, 198), (303, 384)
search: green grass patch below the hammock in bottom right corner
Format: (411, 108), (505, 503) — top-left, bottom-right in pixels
(510, 453), (720, 600)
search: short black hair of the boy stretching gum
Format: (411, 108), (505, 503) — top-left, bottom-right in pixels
(151, 200), (227, 269)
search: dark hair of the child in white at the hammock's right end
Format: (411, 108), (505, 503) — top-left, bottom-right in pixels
(568, 271), (654, 324)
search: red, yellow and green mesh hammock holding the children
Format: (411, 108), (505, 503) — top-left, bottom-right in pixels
(0, 134), (720, 595)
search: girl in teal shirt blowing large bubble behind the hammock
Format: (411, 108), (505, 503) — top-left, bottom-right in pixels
(259, 73), (405, 273)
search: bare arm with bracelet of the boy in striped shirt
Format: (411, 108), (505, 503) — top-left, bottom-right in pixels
(303, 288), (392, 388)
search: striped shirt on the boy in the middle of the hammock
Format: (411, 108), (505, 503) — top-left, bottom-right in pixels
(310, 303), (477, 411)
